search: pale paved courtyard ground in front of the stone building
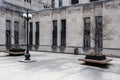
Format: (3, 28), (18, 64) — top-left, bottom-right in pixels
(0, 52), (120, 80)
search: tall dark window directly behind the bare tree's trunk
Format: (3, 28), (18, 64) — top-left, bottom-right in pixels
(95, 16), (103, 48)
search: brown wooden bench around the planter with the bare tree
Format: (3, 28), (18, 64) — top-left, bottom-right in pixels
(78, 59), (112, 64)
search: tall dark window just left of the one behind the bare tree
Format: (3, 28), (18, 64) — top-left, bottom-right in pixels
(84, 17), (90, 47)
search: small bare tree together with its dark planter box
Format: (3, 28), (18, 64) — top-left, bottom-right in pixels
(79, 16), (114, 62)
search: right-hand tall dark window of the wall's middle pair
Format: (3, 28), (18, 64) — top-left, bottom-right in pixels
(61, 19), (66, 46)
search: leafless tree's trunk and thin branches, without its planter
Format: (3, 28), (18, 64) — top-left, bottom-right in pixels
(90, 16), (115, 55)
